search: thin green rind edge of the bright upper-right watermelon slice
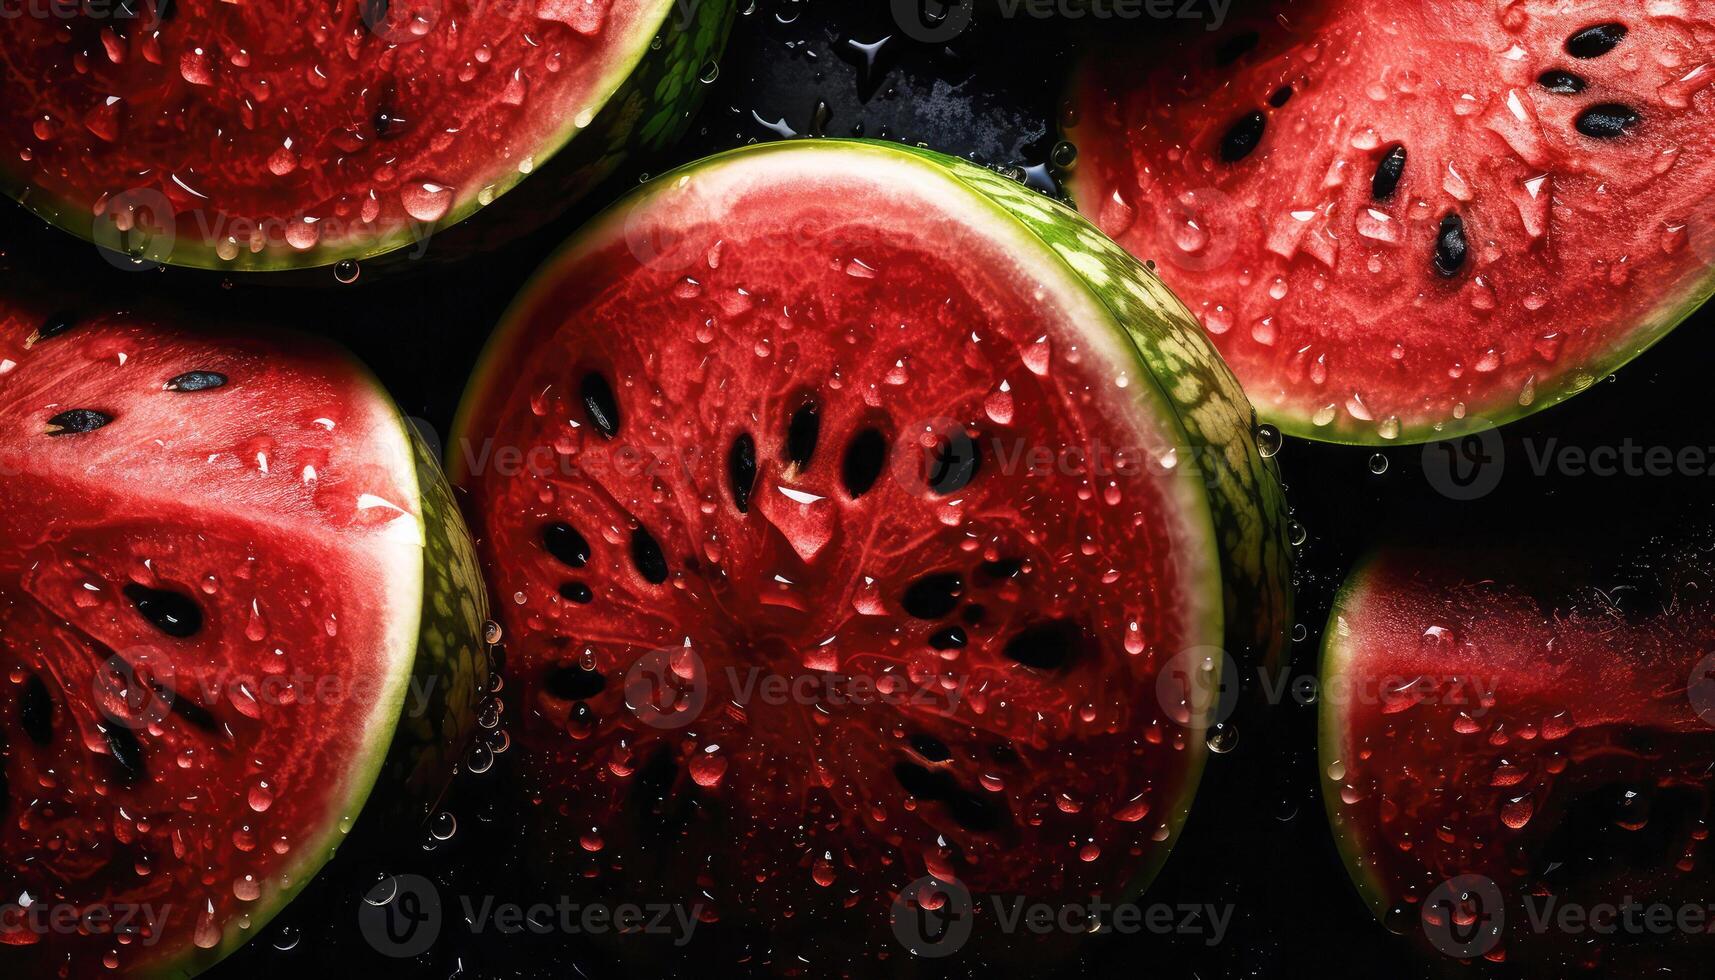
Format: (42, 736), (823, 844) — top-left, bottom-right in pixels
(1062, 70), (1715, 448)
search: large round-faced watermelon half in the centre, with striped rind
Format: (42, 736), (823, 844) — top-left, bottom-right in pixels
(451, 141), (1286, 971)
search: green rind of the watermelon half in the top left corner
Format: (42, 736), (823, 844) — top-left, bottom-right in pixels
(0, 0), (734, 273)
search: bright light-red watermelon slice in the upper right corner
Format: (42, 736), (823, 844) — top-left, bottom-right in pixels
(1070, 0), (1715, 443)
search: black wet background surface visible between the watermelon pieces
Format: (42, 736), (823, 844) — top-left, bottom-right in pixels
(3, 0), (1715, 980)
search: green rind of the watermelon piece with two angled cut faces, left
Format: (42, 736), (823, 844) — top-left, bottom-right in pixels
(141, 387), (490, 980)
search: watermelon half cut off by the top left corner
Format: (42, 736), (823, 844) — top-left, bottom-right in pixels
(0, 0), (732, 269)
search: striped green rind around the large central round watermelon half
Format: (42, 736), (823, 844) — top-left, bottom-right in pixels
(449, 139), (1291, 894)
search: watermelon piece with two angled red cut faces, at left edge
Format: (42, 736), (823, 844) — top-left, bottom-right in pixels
(0, 300), (489, 977)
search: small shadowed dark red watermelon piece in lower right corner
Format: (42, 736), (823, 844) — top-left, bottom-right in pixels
(1321, 551), (1715, 977)
